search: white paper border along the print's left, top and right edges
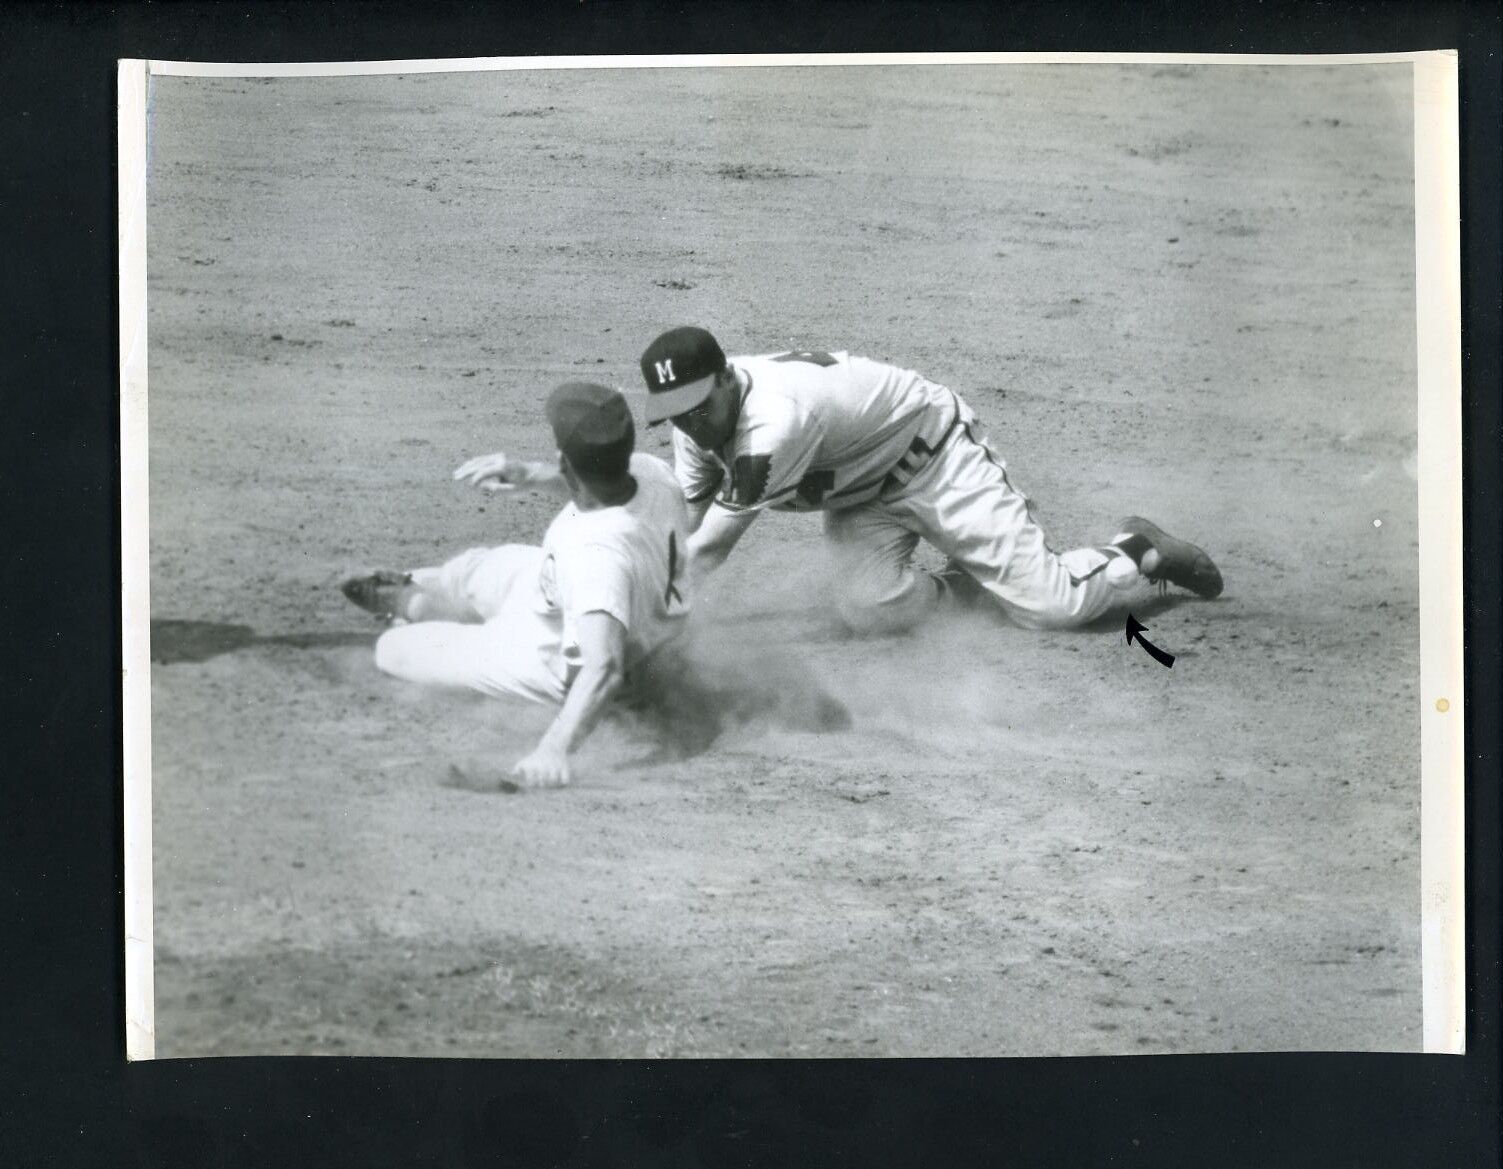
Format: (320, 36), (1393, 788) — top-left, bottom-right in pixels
(119, 50), (1465, 1059)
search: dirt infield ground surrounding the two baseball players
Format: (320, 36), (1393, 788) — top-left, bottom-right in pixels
(149, 59), (1420, 1058)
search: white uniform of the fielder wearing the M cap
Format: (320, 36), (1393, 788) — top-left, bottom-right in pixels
(673, 352), (1153, 628)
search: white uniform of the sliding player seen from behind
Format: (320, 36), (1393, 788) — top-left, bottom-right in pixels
(376, 454), (690, 702)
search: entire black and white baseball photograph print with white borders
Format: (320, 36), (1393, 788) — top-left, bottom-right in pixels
(120, 53), (1462, 1061)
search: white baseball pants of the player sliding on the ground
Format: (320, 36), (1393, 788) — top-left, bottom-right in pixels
(376, 544), (565, 703)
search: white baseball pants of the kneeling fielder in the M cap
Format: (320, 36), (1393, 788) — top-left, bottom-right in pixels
(825, 406), (1154, 631)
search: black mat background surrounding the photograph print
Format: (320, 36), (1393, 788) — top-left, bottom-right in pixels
(0, 2), (1503, 1169)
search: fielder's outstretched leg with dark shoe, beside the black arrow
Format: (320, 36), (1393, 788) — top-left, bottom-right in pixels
(894, 424), (1220, 628)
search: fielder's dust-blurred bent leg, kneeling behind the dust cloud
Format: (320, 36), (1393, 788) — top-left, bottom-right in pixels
(825, 503), (941, 633)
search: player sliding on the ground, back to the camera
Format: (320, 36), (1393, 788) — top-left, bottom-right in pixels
(341, 382), (690, 786)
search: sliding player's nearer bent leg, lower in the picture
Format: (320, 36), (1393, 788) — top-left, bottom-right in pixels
(376, 610), (565, 702)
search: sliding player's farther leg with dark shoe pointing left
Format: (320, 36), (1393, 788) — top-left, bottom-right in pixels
(340, 544), (543, 624)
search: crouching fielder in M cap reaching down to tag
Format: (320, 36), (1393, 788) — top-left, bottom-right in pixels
(642, 326), (1222, 631)
